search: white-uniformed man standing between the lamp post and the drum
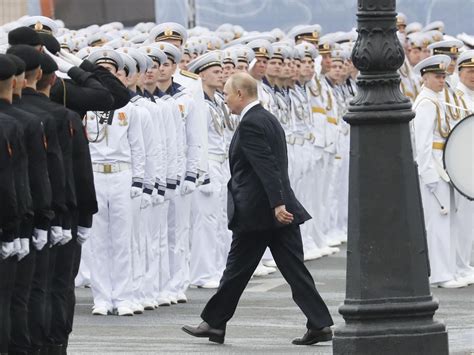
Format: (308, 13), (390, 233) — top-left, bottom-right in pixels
(413, 54), (467, 288)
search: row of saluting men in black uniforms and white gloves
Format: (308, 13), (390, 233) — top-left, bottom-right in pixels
(0, 21), (130, 354)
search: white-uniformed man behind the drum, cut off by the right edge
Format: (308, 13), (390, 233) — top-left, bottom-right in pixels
(451, 50), (474, 285)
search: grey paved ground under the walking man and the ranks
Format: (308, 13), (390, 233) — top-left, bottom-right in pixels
(69, 248), (474, 354)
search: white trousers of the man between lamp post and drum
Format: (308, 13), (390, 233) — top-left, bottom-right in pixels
(421, 180), (456, 283)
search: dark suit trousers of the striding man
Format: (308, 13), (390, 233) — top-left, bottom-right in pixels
(201, 226), (333, 329)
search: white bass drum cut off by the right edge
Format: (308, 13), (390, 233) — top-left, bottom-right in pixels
(443, 114), (474, 201)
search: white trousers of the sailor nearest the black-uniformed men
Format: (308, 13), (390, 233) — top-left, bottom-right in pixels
(89, 170), (133, 310)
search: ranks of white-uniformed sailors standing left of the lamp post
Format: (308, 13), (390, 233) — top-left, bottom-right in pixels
(65, 23), (354, 315)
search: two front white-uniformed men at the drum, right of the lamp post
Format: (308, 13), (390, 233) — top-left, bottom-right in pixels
(412, 49), (474, 288)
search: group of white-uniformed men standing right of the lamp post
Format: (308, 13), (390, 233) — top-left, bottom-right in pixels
(397, 14), (474, 288)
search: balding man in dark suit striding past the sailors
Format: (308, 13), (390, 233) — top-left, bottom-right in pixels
(182, 73), (333, 345)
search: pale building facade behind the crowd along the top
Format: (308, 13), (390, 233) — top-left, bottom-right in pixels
(0, 0), (474, 39)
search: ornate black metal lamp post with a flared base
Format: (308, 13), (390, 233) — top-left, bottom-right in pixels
(333, 0), (448, 355)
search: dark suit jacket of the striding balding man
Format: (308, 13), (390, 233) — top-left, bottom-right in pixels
(227, 104), (311, 233)
